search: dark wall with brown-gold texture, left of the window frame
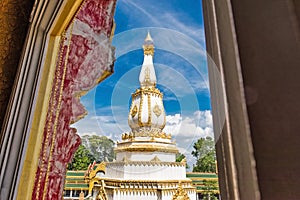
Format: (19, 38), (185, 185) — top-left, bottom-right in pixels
(0, 0), (34, 141)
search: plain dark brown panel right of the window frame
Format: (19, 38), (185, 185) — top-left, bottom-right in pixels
(231, 0), (300, 199)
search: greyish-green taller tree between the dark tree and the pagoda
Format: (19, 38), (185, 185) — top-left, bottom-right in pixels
(81, 135), (115, 163)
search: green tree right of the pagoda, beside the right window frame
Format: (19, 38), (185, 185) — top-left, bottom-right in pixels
(192, 137), (216, 172)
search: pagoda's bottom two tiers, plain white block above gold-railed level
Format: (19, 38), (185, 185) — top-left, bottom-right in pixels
(88, 161), (196, 200)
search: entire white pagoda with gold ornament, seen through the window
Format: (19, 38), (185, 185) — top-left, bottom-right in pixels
(93, 33), (196, 200)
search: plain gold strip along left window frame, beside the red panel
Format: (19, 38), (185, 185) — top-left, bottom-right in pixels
(16, 0), (83, 199)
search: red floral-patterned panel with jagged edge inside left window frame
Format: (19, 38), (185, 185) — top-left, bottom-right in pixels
(32, 0), (115, 199)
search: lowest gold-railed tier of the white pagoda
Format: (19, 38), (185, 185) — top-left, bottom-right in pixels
(93, 178), (196, 200)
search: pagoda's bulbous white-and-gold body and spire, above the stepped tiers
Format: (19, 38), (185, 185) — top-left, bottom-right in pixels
(126, 32), (170, 139)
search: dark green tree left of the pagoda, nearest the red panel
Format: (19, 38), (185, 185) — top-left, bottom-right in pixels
(67, 145), (95, 170)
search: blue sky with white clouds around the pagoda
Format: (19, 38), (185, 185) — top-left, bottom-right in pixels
(73, 0), (213, 169)
